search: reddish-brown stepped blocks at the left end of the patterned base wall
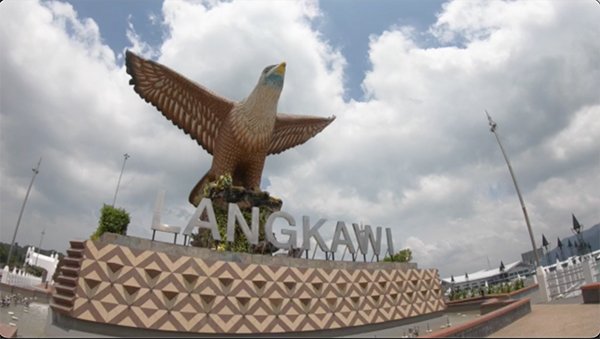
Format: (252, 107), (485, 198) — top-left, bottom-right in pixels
(50, 240), (85, 314)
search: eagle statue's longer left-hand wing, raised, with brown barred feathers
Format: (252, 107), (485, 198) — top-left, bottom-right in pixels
(125, 51), (233, 154)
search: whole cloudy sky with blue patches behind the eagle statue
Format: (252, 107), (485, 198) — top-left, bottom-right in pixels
(0, 0), (600, 277)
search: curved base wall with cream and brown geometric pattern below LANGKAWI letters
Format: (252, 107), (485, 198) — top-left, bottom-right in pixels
(53, 235), (445, 334)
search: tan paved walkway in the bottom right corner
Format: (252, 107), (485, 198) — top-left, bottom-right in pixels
(488, 295), (600, 338)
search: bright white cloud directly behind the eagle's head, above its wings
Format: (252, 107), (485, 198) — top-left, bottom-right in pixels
(160, 1), (344, 115)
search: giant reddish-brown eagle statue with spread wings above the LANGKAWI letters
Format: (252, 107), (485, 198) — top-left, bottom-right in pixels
(125, 51), (335, 206)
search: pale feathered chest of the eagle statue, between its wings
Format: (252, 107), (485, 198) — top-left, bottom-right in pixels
(230, 86), (279, 151)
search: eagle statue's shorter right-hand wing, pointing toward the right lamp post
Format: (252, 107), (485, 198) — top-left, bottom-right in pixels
(268, 113), (335, 154)
